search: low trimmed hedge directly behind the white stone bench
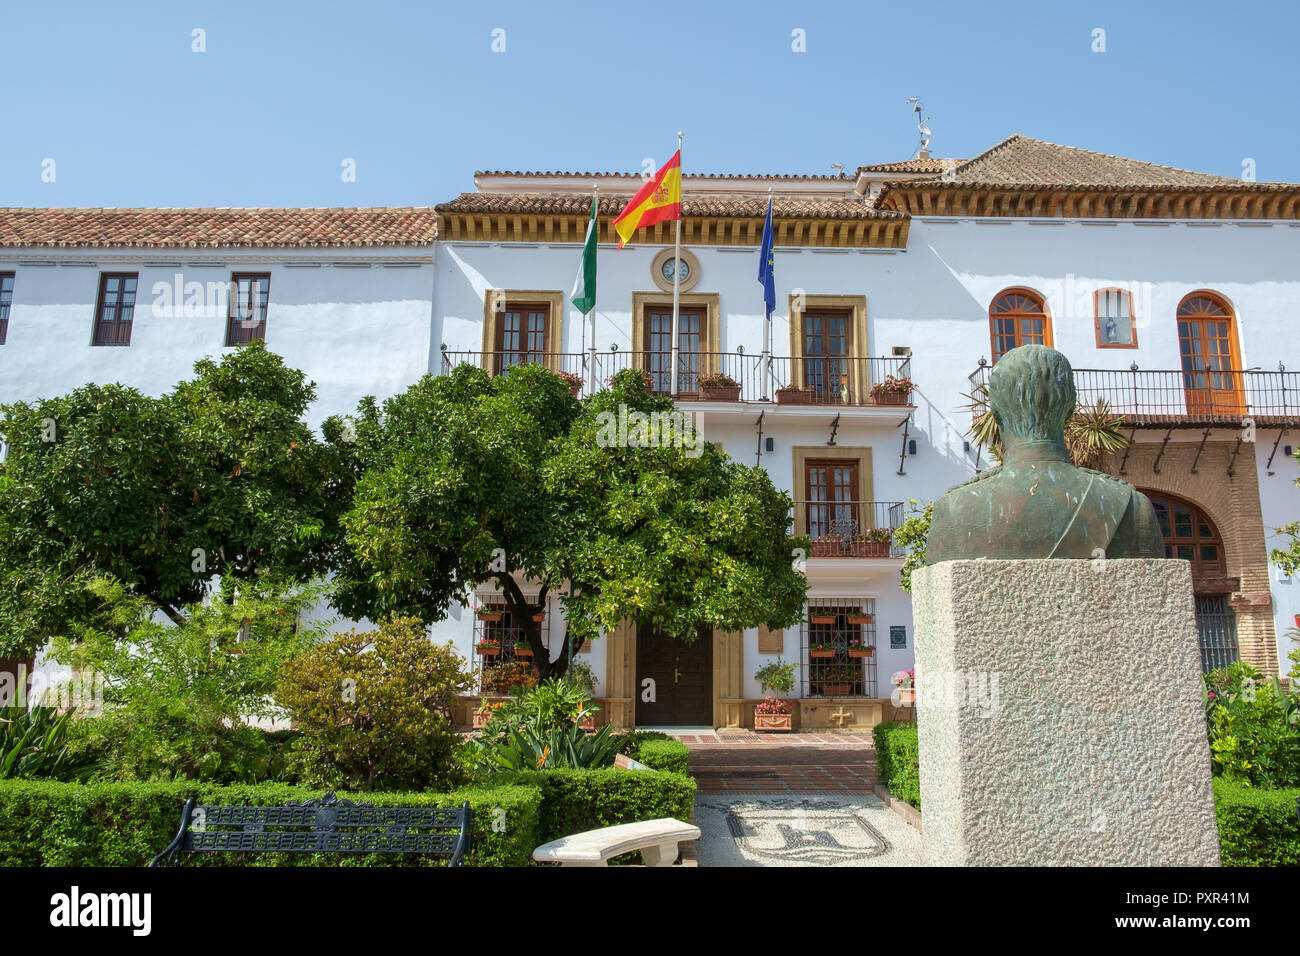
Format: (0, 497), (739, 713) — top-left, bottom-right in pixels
(493, 769), (696, 844)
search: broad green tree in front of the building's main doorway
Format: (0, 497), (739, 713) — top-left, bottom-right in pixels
(338, 364), (806, 678)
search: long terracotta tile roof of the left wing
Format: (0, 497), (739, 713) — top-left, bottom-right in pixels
(0, 207), (438, 248)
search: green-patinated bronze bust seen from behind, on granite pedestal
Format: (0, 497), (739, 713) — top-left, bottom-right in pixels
(926, 345), (1165, 564)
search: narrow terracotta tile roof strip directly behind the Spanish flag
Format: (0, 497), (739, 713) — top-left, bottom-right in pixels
(436, 193), (905, 220)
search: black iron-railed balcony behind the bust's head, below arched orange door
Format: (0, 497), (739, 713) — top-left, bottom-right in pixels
(970, 363), (1300, 428)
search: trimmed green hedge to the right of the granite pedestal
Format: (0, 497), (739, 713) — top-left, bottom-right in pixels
(1214, 779), (1300, 866)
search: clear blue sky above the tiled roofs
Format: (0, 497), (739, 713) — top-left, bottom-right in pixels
(0, 0), (1300, 206)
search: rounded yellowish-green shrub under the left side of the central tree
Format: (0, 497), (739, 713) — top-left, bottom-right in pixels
(277, 618), (473, 791)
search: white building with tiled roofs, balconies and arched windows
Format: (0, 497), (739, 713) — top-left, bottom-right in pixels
(0, 137), (1300, 728)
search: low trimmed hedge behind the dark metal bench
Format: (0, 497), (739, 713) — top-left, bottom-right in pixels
(0, 780), (545, 866)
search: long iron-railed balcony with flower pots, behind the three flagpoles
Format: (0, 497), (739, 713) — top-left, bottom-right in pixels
(442, 349), (911, 410)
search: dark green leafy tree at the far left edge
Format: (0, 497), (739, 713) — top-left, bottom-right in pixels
(0, 341), (355, 654)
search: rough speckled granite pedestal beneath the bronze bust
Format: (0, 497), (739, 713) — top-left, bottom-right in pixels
(911, 559), (1219, 866)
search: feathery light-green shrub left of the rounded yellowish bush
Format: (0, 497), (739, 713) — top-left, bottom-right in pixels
(53, 579), (321, 783)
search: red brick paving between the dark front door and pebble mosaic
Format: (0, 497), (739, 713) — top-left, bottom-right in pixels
(673, 731), (876, 796)
